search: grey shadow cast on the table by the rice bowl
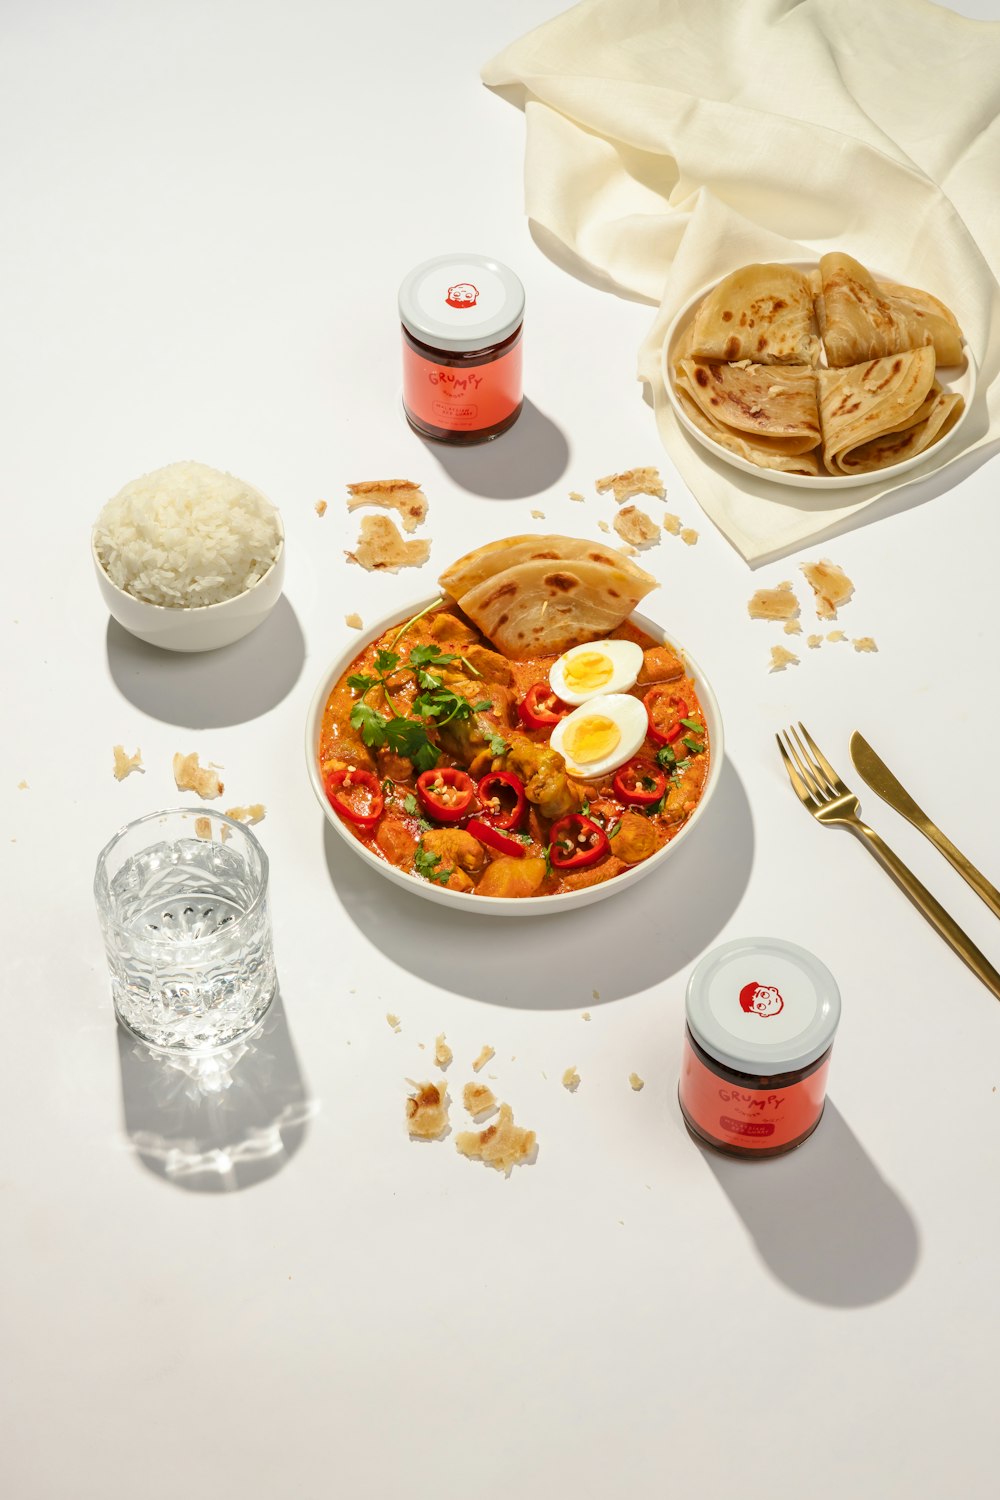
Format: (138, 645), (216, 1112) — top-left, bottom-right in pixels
(108, 594), (306, 729)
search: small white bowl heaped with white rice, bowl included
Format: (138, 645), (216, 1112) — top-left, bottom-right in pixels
(91, 461), (285, 651)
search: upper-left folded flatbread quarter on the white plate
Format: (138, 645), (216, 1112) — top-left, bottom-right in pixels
(690, 266), (820, 365)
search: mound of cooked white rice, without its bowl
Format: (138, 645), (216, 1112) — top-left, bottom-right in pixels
(94, 462), (282, 609)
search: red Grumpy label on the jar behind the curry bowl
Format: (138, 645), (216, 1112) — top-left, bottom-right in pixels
(403, 339), (520, 432)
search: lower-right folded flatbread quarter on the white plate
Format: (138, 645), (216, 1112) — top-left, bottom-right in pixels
(817, 345), (941, 474)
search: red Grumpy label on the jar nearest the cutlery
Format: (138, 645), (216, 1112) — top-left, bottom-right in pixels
(681, 1037), (831, 1151)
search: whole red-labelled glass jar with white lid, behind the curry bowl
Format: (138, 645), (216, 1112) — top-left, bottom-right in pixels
(399, 255), (525, 444)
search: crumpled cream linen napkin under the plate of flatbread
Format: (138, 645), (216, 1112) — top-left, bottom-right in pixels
(483, 0), (1000, 563)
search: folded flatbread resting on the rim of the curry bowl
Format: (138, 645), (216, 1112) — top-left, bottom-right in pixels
(441, 536), (657, 660)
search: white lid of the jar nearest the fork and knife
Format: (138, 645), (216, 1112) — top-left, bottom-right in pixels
(687, 938), (840, 1076)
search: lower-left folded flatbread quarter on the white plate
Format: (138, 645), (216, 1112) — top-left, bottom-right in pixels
(676, 360), (820, 456)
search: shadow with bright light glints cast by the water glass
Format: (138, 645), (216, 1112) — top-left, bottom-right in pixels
(118, 995), (315, 1193)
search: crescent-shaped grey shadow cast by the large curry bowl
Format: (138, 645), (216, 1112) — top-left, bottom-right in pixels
(324, 761), (754, 1010)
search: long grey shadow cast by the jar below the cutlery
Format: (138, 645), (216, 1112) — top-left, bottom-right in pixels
(700, 1100), (921, 1308)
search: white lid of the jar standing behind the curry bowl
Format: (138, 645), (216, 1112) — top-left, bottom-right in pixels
(399, 255), (525, 353)
